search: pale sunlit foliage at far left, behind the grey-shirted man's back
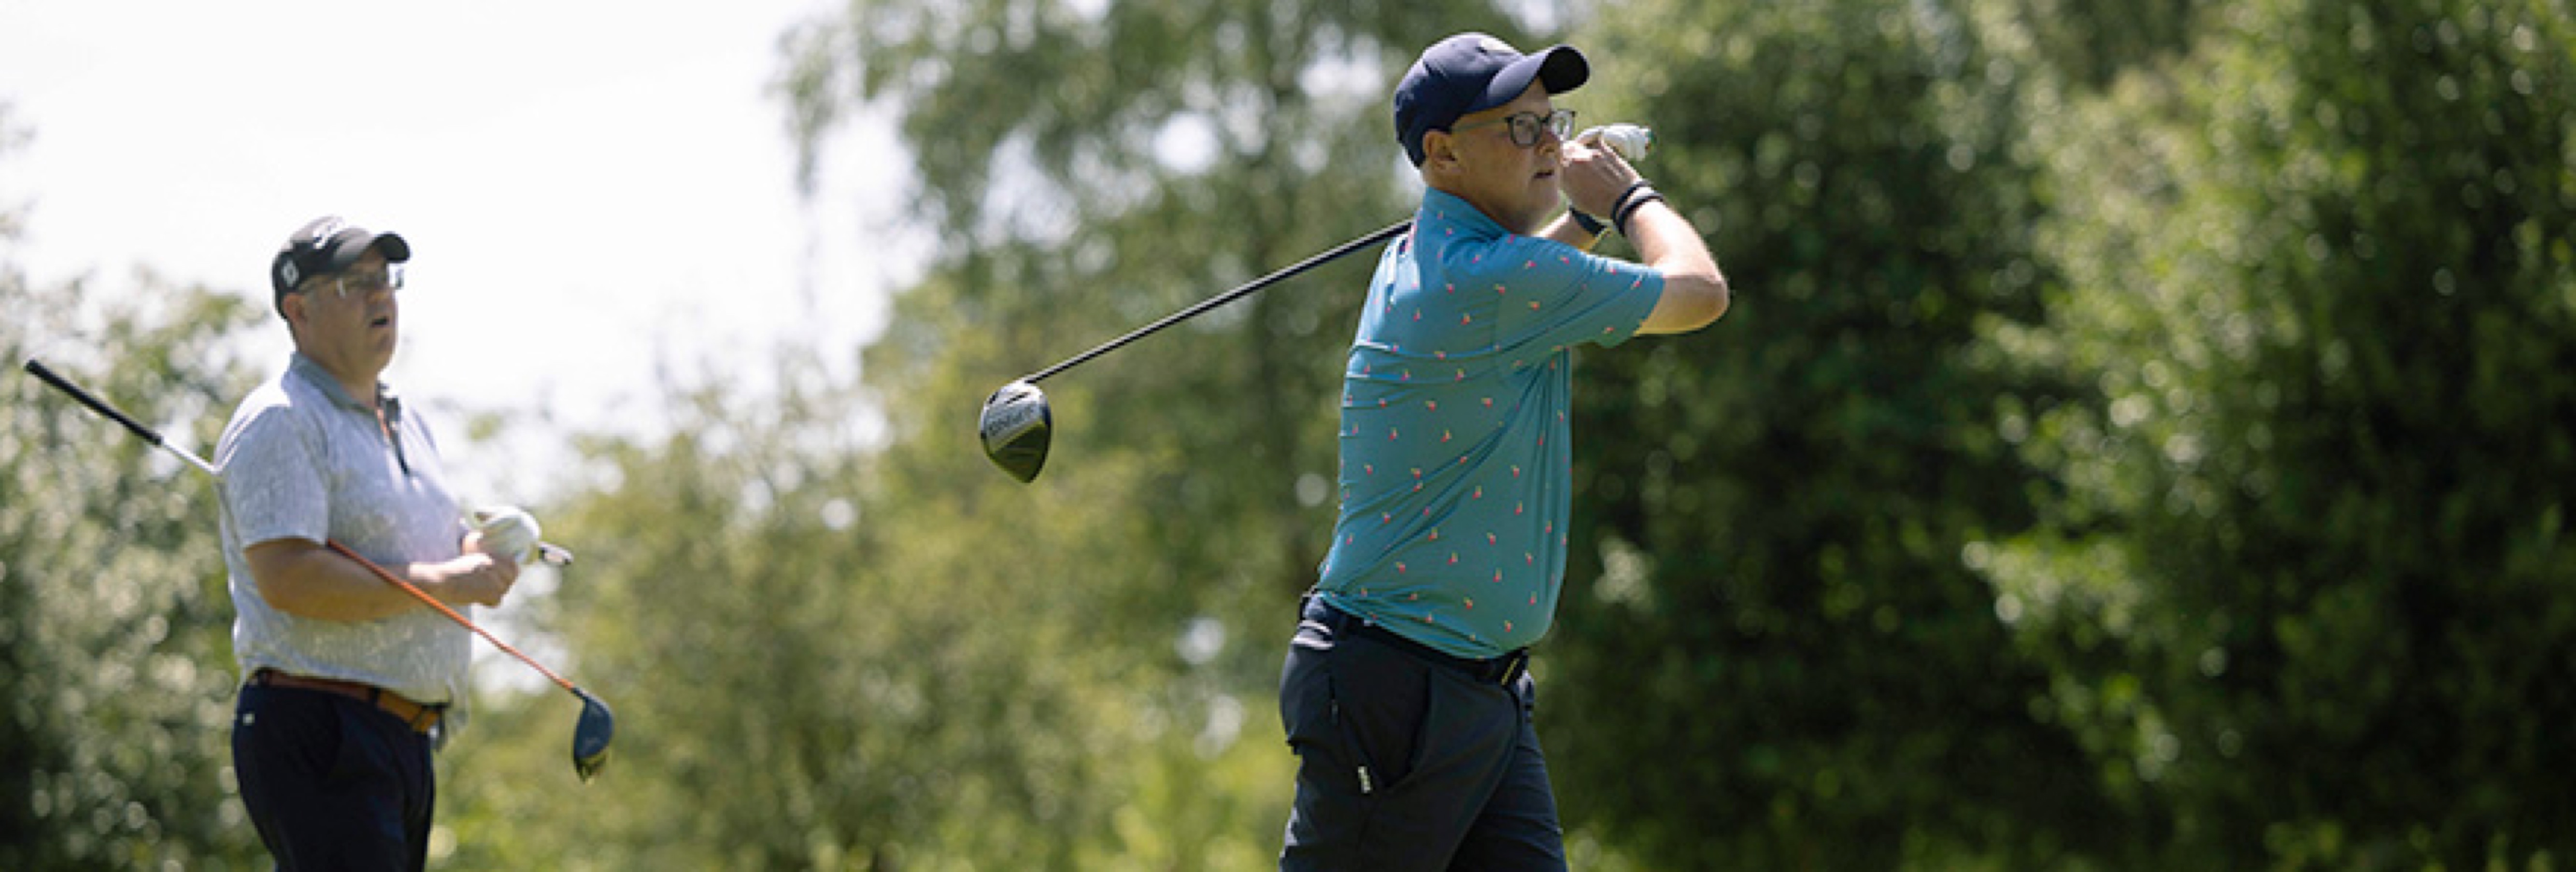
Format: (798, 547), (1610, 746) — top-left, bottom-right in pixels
(0, 113), (263, 870)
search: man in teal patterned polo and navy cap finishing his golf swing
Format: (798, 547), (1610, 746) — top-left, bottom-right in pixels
(1281, 33), (1726, 870)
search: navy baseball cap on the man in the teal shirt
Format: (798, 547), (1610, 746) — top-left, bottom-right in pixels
(1396, 33), (1592, 167)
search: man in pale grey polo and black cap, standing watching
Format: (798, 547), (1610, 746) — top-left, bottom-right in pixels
(214, 219), (533, 870)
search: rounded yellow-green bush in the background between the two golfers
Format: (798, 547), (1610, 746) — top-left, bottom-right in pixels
(448, 332), (1309, 870)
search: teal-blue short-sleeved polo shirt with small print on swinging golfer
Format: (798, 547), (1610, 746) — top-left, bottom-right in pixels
(1316, 190), (1664, 659)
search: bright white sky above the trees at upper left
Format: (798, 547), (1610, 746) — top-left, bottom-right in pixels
(0, 0), (920, 499)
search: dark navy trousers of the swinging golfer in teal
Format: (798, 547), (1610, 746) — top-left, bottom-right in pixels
(1281, 599), (1566, 872)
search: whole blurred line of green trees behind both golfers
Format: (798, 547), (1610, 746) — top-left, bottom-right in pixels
(0, 0), (2576, 870)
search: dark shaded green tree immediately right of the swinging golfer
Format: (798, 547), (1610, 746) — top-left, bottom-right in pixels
(1540, 2), (2107, 870)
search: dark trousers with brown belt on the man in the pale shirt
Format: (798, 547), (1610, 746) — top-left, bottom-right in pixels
(232, 684), (438, 870)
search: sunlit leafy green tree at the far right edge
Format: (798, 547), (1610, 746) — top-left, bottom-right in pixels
(1968, 0), (2576, 867)
